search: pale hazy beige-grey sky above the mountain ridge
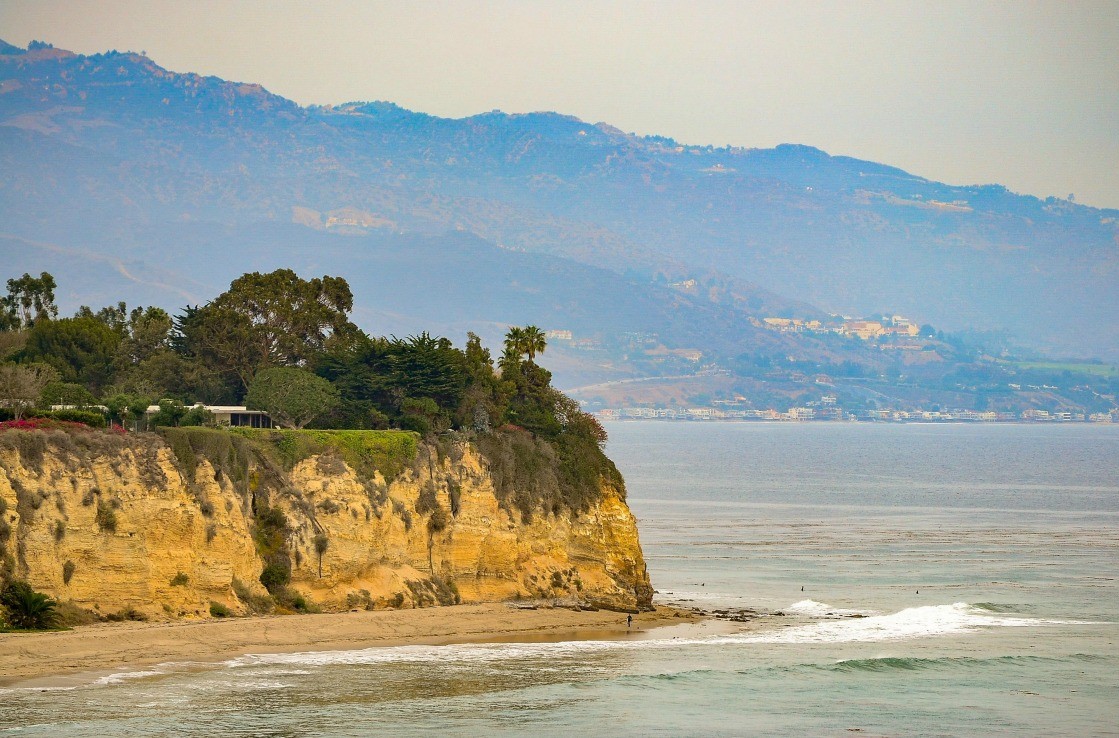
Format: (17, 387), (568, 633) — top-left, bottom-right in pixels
(0, 0), (1119, 207)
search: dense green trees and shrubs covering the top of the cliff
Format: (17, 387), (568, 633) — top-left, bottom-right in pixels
(0, 269), (621, 512)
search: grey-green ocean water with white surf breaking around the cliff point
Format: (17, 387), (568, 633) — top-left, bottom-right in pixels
(0, 423), (1119, 736)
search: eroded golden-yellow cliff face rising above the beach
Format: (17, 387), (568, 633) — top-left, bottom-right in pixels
(0, 431), (652, 618)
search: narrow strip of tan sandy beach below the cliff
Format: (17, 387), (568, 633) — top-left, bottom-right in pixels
(0, 603), (698, 687)
